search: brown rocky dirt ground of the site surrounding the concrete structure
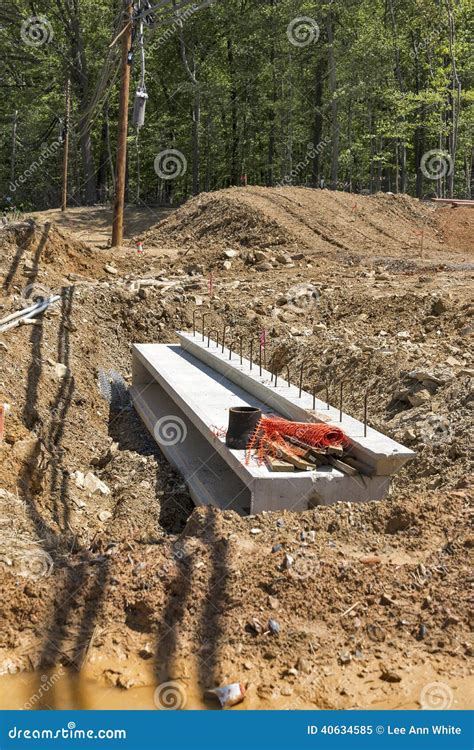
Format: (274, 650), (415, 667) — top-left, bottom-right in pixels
(0, 187), (474, 709)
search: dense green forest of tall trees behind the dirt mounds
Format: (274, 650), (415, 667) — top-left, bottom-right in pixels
(0, 0), (474, 209)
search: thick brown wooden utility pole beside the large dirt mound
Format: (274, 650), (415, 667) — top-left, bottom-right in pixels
(112, 0), (132, 247)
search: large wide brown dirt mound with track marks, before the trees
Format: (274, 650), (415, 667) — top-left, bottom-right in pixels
(143, 187), (465, 259)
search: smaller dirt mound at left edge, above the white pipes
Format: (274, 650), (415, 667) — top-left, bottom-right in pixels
(0, 220), (102, 297)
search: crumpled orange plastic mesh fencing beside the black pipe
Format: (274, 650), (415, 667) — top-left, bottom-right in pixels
(245, 417), (350, 464)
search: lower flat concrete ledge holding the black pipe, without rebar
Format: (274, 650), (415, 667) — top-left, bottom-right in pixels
(131, 344), (389, 513)
